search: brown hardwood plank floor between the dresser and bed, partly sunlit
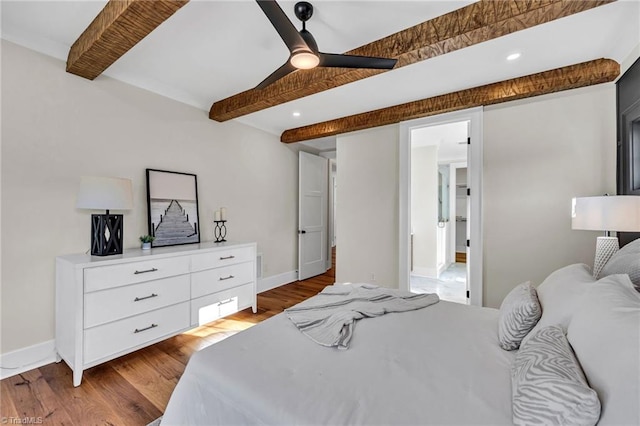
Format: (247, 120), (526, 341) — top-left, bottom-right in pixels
(0, 268), (335, 426)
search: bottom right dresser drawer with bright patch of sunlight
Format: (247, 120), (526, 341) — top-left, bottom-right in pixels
(191, 283), (255, 327)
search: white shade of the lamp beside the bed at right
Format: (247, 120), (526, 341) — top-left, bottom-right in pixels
(571, 195), (640, 232)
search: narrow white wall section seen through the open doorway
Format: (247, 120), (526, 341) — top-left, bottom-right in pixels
(411, 145), (438, 278)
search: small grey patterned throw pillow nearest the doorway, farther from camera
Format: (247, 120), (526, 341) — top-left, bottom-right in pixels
(498, 281), (542, 351)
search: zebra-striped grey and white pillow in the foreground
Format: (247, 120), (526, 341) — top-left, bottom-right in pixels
(511, 326), (600, 425)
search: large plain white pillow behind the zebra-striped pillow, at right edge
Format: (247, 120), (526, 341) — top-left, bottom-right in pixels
(567, 275), (640, 425)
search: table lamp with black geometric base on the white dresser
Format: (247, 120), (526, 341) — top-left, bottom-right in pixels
(76, 176), (133, 256)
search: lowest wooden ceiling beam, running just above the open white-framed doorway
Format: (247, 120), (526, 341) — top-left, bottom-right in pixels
(280, 59), (620, 143)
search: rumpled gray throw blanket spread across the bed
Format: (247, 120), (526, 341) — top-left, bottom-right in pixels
(285, 284), (440, 349)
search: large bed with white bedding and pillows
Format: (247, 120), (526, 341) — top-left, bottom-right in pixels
(161, 251), (640, 425)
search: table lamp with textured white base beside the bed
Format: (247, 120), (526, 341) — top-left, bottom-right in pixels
(571, 195), (640, 278)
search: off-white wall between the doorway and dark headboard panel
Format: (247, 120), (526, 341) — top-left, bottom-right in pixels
(483, 83), (616, 307)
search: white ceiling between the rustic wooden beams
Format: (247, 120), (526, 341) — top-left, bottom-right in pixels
(0, 0), (640, 148)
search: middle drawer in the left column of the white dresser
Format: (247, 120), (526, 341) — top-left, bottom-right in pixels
(84, 275), (190, 328)
